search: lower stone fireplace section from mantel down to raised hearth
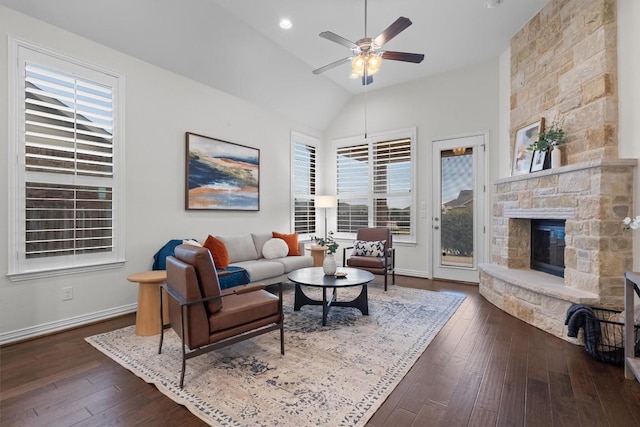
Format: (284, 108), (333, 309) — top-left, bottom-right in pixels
(480, 159), (637, 339)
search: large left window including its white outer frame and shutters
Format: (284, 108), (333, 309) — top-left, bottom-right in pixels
(9, 40), (124, 279)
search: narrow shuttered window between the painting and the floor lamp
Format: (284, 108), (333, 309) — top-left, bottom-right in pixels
(291, 132), (317, 237)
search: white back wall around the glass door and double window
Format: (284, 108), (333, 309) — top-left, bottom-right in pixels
(325, 58), (499, 277)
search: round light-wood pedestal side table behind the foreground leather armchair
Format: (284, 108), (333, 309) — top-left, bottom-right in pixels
(127, 270), (169, 336)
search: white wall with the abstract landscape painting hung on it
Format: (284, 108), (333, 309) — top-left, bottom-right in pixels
(0, 7), (320, 342)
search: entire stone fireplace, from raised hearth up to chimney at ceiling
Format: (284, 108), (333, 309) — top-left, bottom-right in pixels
(480, 0), (637, 342)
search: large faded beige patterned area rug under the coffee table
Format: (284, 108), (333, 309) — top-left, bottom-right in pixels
(86, 285), (464, 427)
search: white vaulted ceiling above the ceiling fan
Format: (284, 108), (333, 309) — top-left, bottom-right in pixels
(0, 0), (548, 130)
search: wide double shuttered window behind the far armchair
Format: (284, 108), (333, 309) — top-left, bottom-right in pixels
(336, 131), (415, 241)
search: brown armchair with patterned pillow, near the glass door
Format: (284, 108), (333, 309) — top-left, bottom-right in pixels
(342, 227), (396, 291)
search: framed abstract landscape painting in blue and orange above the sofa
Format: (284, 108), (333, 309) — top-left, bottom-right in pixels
(185, 132), (260, 211)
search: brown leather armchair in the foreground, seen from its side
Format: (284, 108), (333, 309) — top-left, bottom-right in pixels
(158, 245), (284, 388)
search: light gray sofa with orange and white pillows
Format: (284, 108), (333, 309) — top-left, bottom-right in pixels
(215, 233), (313, 285)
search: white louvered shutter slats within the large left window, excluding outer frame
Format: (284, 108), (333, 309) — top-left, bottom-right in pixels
(24, 62), (114, 259)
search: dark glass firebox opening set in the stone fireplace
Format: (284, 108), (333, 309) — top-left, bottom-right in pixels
(531, 219), (565, 277)
